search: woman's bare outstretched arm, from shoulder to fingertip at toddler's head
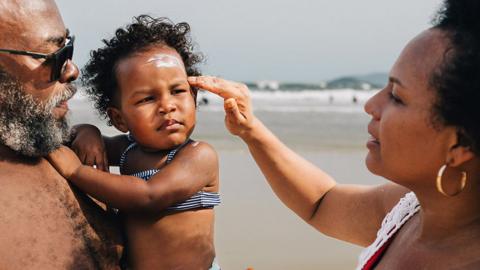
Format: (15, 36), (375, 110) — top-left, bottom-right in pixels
(189, 76), (407, 245)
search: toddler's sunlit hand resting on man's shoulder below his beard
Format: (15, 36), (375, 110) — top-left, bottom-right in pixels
(47, 145), (82, 179)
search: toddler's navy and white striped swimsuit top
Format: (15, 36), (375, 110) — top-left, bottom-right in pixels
(120, 135), (220, 211)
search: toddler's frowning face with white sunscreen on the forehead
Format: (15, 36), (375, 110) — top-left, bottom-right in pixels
(116, 46), (195, 151)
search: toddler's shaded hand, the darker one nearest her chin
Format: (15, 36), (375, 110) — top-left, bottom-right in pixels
(71, 124), (109, 172)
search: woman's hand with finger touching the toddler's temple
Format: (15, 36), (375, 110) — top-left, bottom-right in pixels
(188, 76), (256, 138)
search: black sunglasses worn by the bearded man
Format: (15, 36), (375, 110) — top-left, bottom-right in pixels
(0, 36), (75, 82)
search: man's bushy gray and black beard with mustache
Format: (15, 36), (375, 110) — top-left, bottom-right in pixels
(0, 71), (76, 157)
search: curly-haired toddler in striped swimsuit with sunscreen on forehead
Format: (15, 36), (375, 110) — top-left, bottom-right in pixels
(49, 15), (220, 270)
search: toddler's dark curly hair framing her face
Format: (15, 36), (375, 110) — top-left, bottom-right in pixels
(82, 15), (203, 125)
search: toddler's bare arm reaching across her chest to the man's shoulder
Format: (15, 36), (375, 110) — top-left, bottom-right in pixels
(48, 143), (218, 214)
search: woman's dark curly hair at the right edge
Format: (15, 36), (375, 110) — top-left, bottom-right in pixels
(430, 0), (480, 155)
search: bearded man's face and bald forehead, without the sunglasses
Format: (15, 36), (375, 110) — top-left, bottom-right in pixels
(0, 0), (78, 156)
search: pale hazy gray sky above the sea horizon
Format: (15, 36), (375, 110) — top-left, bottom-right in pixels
(57, 0), (442, 82)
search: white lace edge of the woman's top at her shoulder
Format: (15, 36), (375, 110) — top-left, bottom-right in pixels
(356, 192), (420, 270)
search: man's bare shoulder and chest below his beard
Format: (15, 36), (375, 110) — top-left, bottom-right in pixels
(0, 159), (121, 269)
